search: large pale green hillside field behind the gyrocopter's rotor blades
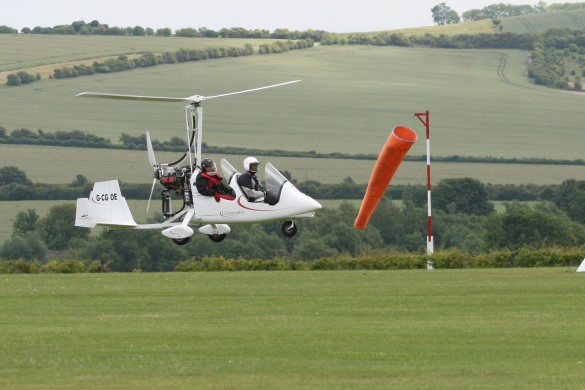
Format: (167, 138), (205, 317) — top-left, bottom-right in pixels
(0, 41), (585, 159)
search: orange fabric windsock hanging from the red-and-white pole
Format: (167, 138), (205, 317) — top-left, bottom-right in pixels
(353, 126), (418, 229)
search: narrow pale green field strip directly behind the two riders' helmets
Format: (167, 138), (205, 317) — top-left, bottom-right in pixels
(5, 145), (585, 185)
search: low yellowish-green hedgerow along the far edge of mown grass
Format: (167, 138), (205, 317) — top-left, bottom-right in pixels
(0, 246), (585, 274)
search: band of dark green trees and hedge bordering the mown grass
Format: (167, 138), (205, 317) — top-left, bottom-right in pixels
(0, 178), (585, 272)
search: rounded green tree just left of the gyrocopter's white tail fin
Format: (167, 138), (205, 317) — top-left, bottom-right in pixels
(37, 204), (89, 250)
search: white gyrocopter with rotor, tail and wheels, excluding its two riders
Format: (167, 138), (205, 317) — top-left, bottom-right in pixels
(75, 80), (321, 245)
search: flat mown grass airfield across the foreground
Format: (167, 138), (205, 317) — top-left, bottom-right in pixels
(0, 268), (585, 389)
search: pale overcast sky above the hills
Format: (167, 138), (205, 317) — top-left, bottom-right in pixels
(0, 0), (538, 33)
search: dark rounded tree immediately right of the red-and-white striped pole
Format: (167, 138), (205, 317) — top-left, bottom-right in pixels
(433, 177), (494, 215)
